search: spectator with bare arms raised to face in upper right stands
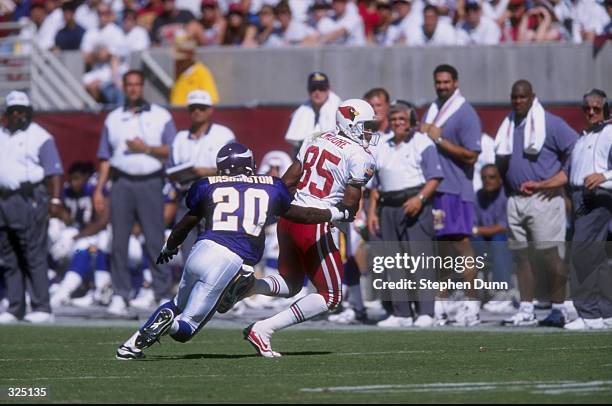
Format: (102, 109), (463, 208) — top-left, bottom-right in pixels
(518, 1), (562, 42)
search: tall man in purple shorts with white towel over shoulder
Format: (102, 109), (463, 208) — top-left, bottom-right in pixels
(421, 65), (482, 326)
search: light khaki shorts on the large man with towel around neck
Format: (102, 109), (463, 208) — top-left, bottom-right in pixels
(508, 194), (567, 250)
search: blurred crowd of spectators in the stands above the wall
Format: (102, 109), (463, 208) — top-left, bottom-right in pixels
(0, 0), (612, 107)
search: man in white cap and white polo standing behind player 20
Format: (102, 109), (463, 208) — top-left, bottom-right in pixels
(169, 90), (236, 258)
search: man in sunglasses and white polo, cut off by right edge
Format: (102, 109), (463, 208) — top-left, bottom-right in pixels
(564, 89), (612, 330)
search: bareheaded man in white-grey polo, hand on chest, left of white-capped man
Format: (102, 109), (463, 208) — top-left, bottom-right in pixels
(94, 70), (176, 315)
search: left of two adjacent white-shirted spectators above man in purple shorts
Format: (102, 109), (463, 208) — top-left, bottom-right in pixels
(406, 4), (456, 46)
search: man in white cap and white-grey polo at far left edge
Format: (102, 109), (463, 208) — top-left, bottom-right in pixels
(0, 91), (63, 323)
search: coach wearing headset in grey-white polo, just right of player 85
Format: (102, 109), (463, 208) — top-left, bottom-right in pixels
(368, 101), (444, 327)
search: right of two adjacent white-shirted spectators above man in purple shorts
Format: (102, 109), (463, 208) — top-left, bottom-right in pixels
(457, 0), (501, 45)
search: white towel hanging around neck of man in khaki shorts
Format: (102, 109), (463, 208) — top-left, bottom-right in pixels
(495, 97), (546, 155)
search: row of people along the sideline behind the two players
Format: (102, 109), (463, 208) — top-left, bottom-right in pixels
(0, 61), (612, 330)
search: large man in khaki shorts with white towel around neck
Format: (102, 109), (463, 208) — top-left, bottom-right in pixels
(496, 80), (578, 327)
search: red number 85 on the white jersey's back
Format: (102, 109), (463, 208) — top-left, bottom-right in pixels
(297, 145), (341, 198)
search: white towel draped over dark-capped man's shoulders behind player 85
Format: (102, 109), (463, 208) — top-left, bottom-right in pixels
(285, 91), (341, 141)
